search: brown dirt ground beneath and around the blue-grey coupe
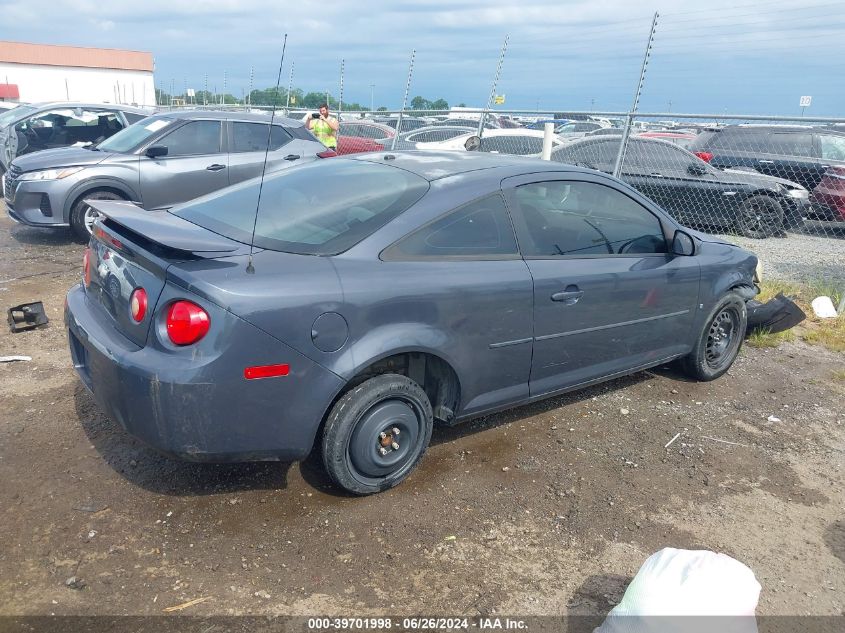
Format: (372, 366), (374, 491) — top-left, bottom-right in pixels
(0, 209), (845, 616)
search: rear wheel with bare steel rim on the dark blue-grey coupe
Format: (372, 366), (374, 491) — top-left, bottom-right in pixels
(322, 374), (434, 495)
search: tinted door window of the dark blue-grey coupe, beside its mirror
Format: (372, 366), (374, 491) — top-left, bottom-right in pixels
(514, 181), (667, 257)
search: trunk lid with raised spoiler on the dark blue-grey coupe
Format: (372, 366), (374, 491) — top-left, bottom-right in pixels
(85, 200), (248, 347)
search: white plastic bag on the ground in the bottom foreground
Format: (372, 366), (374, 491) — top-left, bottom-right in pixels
(596, 547), (760, 633)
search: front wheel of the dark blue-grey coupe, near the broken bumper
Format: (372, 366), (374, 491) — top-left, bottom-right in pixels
(680, 292), (748, 382)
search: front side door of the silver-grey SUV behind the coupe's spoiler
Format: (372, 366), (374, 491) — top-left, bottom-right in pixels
(138, 119), (229, 209)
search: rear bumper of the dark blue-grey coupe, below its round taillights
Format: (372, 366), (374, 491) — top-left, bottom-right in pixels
(65, 285), (343, 462)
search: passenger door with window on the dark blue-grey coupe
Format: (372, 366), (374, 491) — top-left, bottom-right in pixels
(502, 174), (700, 397)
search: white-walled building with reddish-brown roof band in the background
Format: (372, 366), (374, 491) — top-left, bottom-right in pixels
(0, 41), (155, 106)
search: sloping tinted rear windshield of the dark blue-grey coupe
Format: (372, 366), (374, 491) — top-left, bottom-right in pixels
(170, 158), (429, 255)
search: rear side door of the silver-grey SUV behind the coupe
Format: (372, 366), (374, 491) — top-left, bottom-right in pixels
(229, 121), (303, 185)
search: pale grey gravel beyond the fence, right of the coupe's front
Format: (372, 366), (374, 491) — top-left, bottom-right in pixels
(721, 223), (845, 292)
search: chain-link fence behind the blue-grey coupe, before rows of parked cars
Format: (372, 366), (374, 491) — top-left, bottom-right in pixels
(312, 110), (845, 293)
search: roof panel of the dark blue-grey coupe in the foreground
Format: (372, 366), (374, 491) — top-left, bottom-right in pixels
(346, 150), (594, 182)
